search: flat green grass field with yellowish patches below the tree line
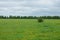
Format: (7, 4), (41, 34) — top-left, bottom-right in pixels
(0, 19), (60, 40)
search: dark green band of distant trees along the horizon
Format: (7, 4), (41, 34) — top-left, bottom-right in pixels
(0, 16), (60, 19)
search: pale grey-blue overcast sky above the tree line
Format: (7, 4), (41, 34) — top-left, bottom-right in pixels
(0, 0), (60, 16)
